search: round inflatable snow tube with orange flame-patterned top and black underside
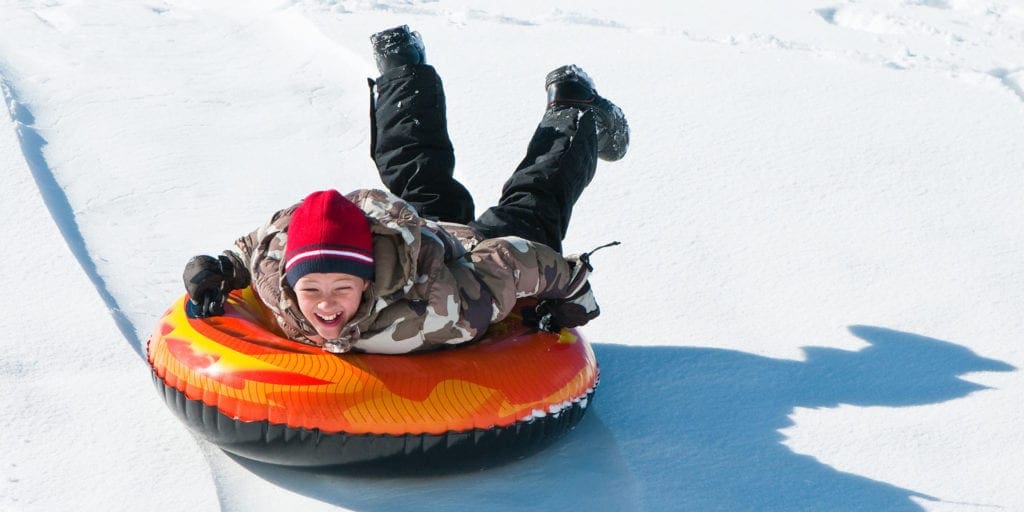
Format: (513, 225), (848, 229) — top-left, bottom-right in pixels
(147, 289), (598, 466)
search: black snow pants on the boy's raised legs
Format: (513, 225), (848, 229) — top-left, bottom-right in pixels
(371, 66), (597, 252)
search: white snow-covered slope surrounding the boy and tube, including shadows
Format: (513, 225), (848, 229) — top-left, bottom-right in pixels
(0, 0), (1024, 511)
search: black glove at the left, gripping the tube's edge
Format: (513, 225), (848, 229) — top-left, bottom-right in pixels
(182, 255), (249, 318)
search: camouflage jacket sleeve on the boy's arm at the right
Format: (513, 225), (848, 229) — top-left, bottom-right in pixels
(469, 237), (579, 322)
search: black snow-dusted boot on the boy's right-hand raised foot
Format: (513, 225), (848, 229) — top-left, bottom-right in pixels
(544, 65), (630, 162)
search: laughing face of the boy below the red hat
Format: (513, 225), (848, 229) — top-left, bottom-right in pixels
(294, 272), (370, 339)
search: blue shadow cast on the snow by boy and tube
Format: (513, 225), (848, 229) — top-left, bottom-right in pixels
(237, 326), (1015, 511)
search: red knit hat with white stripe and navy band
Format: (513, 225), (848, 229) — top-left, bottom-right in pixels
(285, 190), (374, 286)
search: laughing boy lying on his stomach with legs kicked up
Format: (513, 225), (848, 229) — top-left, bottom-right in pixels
(183, 26), (629, 353)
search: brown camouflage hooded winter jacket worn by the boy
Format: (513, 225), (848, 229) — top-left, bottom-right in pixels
(225, 189), (589, 353)
